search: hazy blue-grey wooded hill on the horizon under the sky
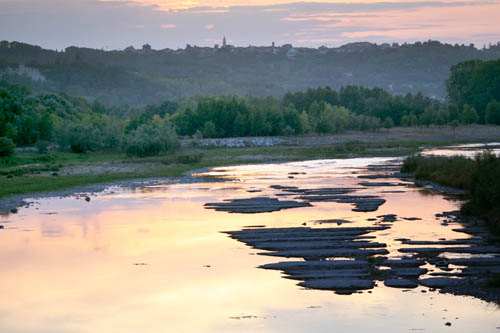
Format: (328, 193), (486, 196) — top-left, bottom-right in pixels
(0, 41), (500, 105)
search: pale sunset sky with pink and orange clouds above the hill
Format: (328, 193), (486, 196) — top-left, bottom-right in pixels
(0, 0), (500, 49)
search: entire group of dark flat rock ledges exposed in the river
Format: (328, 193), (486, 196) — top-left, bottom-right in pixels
(210, 163), (500, 302)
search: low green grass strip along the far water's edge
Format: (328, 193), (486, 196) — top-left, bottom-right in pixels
(0, 141), (430, 198)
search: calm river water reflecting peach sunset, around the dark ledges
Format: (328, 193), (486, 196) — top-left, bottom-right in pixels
(0, 145), (500, 332)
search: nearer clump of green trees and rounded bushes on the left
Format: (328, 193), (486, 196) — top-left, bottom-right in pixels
(0, 82), (178, 156)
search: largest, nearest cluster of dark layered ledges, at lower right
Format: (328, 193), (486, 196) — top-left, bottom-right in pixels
(224, 212), (500, 302)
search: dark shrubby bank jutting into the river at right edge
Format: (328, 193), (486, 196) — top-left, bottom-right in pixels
(401, 152), (500, 233)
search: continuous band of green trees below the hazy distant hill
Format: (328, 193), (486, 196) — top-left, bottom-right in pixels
(0, 60), (500, 156)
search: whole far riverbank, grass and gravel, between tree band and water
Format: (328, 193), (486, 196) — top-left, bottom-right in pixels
(0, 125), (500, 212)
